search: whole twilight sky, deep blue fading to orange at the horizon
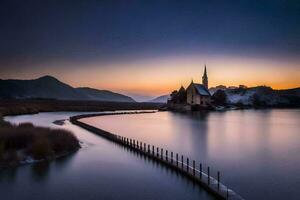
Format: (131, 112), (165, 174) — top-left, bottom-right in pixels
(0, 0), (300, 96)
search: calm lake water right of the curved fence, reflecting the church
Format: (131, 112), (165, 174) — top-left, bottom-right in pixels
(82, 110), (300, 199)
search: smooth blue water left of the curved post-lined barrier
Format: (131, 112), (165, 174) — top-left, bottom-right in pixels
(0, 112), (213, 200)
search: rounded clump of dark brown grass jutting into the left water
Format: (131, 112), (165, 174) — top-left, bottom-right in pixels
(0, 116), (80, 163)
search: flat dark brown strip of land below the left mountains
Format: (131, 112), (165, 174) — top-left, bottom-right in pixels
(0, 99), (163, 116)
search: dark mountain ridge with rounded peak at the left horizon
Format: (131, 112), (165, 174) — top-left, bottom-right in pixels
(0, 76), (134, 102)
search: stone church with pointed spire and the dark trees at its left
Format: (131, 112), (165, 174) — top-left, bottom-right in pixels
(168, 65), (211, 110)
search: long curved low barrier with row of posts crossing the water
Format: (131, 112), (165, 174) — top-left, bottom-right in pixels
(70, 111), (243, 200)
